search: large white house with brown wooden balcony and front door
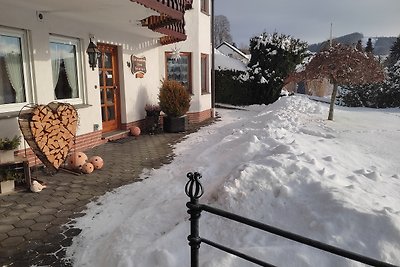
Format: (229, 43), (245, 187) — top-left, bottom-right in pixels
(0, 0), (212, 165)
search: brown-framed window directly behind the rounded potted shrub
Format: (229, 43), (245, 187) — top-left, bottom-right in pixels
(165, 52), (192, 93)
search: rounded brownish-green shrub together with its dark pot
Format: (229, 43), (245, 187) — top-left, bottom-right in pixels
(158, 80), (191, 133)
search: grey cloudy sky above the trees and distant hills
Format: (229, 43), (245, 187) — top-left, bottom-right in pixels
(214, 0), (400, 47)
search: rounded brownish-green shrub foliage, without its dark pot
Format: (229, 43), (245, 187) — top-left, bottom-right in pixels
(158, 79), (191, 117)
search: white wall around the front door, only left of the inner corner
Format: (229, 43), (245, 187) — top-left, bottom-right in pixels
(0, 1), (161, 136)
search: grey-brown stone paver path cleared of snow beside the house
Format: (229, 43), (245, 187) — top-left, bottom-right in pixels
(0, 122), (209, 267)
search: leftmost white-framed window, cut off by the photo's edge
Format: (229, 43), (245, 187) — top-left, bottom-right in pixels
(0, 27), (29, 111)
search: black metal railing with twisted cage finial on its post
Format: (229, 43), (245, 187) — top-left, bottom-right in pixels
(185, 172), (399, 267)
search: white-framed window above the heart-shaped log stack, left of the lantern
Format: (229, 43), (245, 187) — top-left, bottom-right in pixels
(50, 36), (83, 103)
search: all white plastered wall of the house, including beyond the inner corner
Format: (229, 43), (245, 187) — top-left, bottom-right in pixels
(0, 1), (211, 148)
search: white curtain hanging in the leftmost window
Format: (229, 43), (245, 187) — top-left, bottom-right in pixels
(4, 53), (25, 103)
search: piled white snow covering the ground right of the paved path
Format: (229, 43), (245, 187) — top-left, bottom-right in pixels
(67, 95), (400, 267)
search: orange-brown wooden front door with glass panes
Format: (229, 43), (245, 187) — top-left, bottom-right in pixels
(98, 44), (121, 132)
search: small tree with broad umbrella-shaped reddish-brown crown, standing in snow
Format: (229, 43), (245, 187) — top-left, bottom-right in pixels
(286, 44), (385, 120)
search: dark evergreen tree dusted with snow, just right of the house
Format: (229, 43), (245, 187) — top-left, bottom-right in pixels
(248, 32), (307, 104)
